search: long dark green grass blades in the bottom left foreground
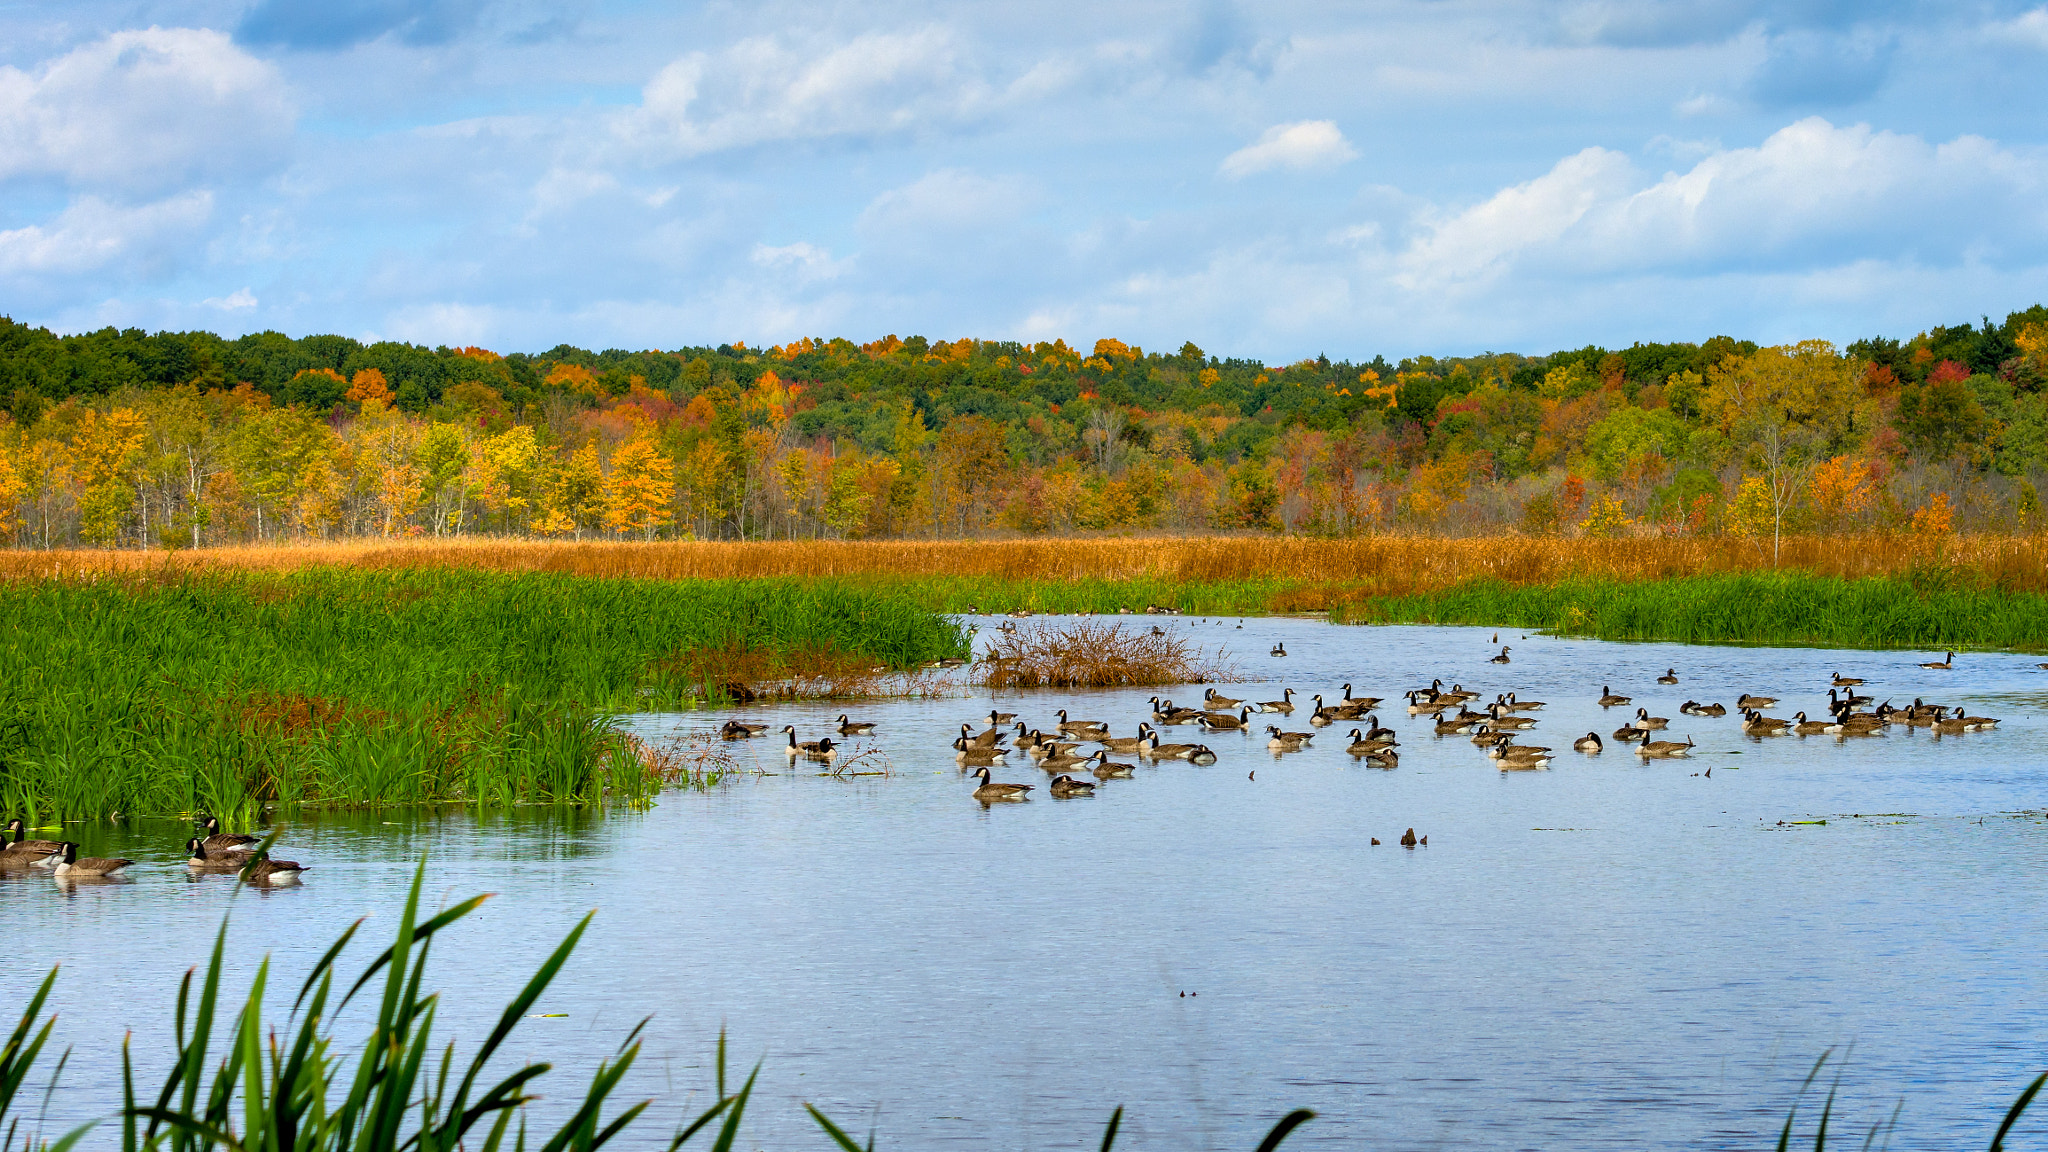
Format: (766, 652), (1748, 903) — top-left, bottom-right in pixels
(0, 859), (1315, 1152)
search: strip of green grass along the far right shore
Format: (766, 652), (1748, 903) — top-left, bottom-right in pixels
(1331, 572), (2048, 650)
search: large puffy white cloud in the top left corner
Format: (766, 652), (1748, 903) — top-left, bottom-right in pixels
(0, 27), (293, 193)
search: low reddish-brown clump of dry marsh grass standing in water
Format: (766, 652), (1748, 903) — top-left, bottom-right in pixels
(971, 623), (1237, 691)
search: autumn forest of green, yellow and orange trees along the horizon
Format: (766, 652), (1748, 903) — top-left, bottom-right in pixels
(0, 305), (2048, 549)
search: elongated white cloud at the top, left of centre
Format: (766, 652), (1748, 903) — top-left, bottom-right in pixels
(631, 29), (987, 156)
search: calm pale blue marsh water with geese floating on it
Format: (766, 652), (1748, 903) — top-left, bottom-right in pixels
(0, 619), (2048, 1150)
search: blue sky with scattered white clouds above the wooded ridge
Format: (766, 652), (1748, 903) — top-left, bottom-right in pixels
(0, 0), (2048, 363)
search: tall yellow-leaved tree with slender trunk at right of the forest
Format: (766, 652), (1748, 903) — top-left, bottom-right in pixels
(1700, 340), (1864, 564)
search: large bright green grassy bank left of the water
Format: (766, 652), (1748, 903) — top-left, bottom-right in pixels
(0, 568), (961, 818)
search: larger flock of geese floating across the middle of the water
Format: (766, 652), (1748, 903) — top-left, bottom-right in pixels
(721, 646), (1999, 804)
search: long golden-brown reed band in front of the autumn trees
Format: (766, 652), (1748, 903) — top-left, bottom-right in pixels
(0, 533), (2048, 594)
